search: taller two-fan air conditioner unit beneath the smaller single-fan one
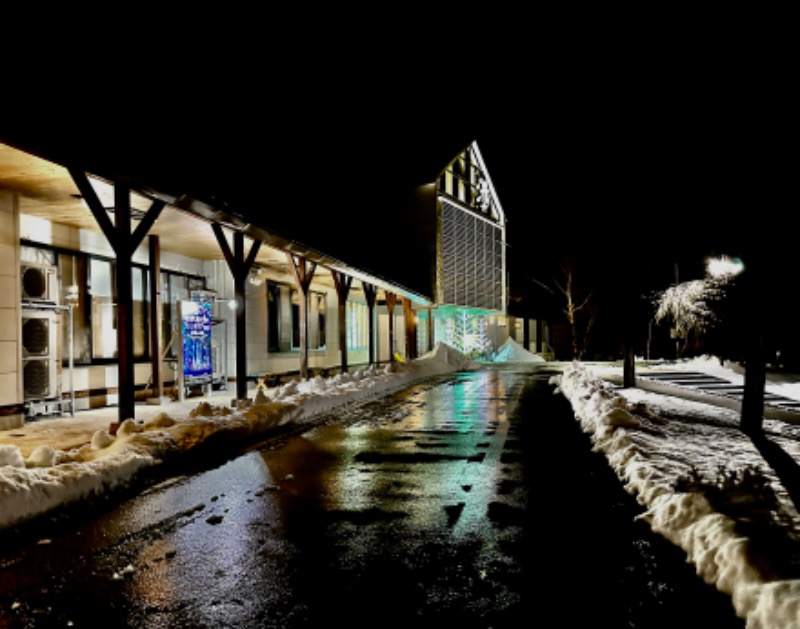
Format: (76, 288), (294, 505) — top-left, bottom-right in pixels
(22, 309), (61, 401)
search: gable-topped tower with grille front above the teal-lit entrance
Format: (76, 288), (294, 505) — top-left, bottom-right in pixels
(436, 142), (507, 314)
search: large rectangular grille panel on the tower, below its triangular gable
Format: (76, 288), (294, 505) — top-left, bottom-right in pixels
(440, 201), (504, 311)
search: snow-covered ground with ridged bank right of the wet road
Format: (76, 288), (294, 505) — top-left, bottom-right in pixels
(552, 359), (800, 629)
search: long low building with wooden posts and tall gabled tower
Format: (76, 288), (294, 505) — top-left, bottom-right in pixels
(0, 136), (513, 428)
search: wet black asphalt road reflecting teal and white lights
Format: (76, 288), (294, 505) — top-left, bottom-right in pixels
(0, 366), (744, 628)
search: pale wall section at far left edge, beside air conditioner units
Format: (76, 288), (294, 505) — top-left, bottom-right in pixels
(0, 190), (24, 430)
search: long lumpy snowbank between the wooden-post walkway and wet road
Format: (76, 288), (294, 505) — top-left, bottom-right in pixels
(0, 344), (479, 528)
